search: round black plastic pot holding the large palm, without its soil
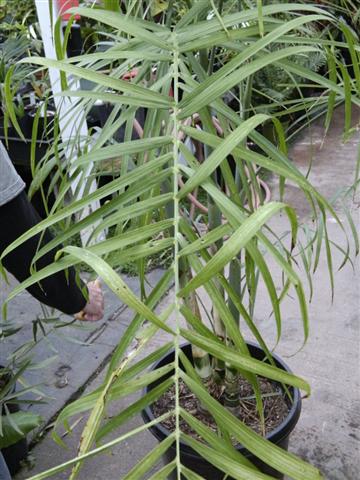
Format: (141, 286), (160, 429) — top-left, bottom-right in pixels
(142, 343), (301, 480)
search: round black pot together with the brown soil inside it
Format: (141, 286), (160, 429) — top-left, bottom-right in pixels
(142, 344), (301, 480)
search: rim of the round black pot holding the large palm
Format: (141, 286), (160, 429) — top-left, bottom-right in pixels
(141, 341), (301, 456)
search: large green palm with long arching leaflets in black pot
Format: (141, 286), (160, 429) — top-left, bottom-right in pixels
(3, 0), (360, 480)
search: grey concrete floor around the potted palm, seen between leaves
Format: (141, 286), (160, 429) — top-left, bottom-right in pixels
(2, 108), (360, 480)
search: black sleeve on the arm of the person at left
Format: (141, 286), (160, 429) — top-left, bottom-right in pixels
(0, 192), (86, 314)
